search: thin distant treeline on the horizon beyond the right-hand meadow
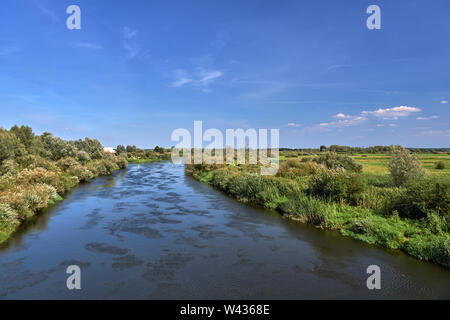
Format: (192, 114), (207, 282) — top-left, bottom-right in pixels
(280, 144), (450, 153)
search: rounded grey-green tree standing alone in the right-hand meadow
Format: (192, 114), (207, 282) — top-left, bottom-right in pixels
(389, 146), (425, 186)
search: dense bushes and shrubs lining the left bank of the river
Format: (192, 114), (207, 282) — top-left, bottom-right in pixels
(0, 126), (168, 243)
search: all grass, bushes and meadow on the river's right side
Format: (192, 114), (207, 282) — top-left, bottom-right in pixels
(185, 146), (450, 268)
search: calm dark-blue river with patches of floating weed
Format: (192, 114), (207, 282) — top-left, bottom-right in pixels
(0, 163), (450, 299)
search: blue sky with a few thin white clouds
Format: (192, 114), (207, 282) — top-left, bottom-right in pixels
(0, 0), (450, 148)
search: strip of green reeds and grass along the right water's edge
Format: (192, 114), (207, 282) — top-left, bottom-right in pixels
(186, 165), (450, 268)
